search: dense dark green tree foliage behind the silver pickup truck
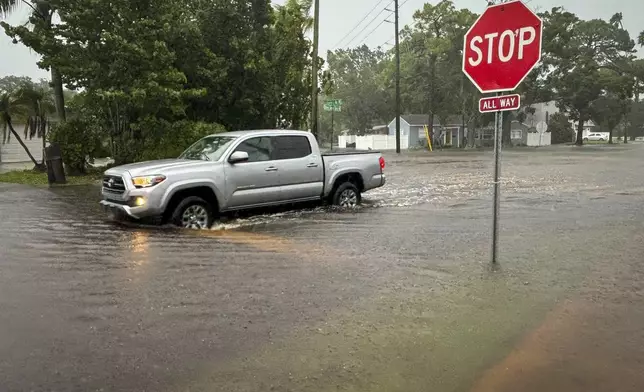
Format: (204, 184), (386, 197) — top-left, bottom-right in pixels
(3, 0), (322, 165)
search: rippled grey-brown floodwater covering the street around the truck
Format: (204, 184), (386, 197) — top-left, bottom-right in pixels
(0, 145), (644, 392)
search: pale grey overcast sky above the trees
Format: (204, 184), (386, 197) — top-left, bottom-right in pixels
(0, 0), (644, 78)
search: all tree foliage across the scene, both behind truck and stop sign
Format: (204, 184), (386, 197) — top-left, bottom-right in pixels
(0, 0), (644, 156)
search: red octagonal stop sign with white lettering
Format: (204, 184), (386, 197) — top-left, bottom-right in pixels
(463, 0), (543, 93)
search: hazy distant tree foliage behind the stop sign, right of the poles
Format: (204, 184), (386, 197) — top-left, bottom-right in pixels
(325, 1), (644, 149)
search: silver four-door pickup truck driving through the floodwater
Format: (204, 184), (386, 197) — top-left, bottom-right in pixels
(100, 130), (385, 229)
